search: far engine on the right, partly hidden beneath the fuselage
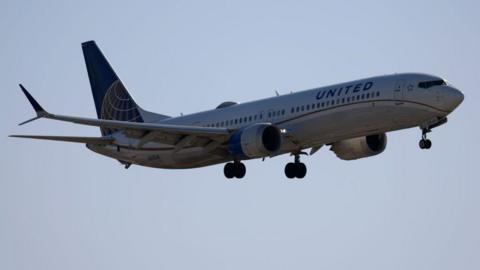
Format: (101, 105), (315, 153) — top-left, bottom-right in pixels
(330, 133), (387, 160)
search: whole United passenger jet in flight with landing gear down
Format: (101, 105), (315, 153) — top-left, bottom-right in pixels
(10, 41), (464, 179)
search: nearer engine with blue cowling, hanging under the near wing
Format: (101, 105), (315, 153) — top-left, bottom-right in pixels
(228, 123), (282, 158)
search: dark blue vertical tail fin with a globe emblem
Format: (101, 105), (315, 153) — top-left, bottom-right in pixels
(82, 41), (144, 135)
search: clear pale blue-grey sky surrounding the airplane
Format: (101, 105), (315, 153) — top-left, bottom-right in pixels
(0, 0), (480, 270)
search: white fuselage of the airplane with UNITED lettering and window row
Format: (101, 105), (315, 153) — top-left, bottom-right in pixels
(88, 73), (463, 168)
